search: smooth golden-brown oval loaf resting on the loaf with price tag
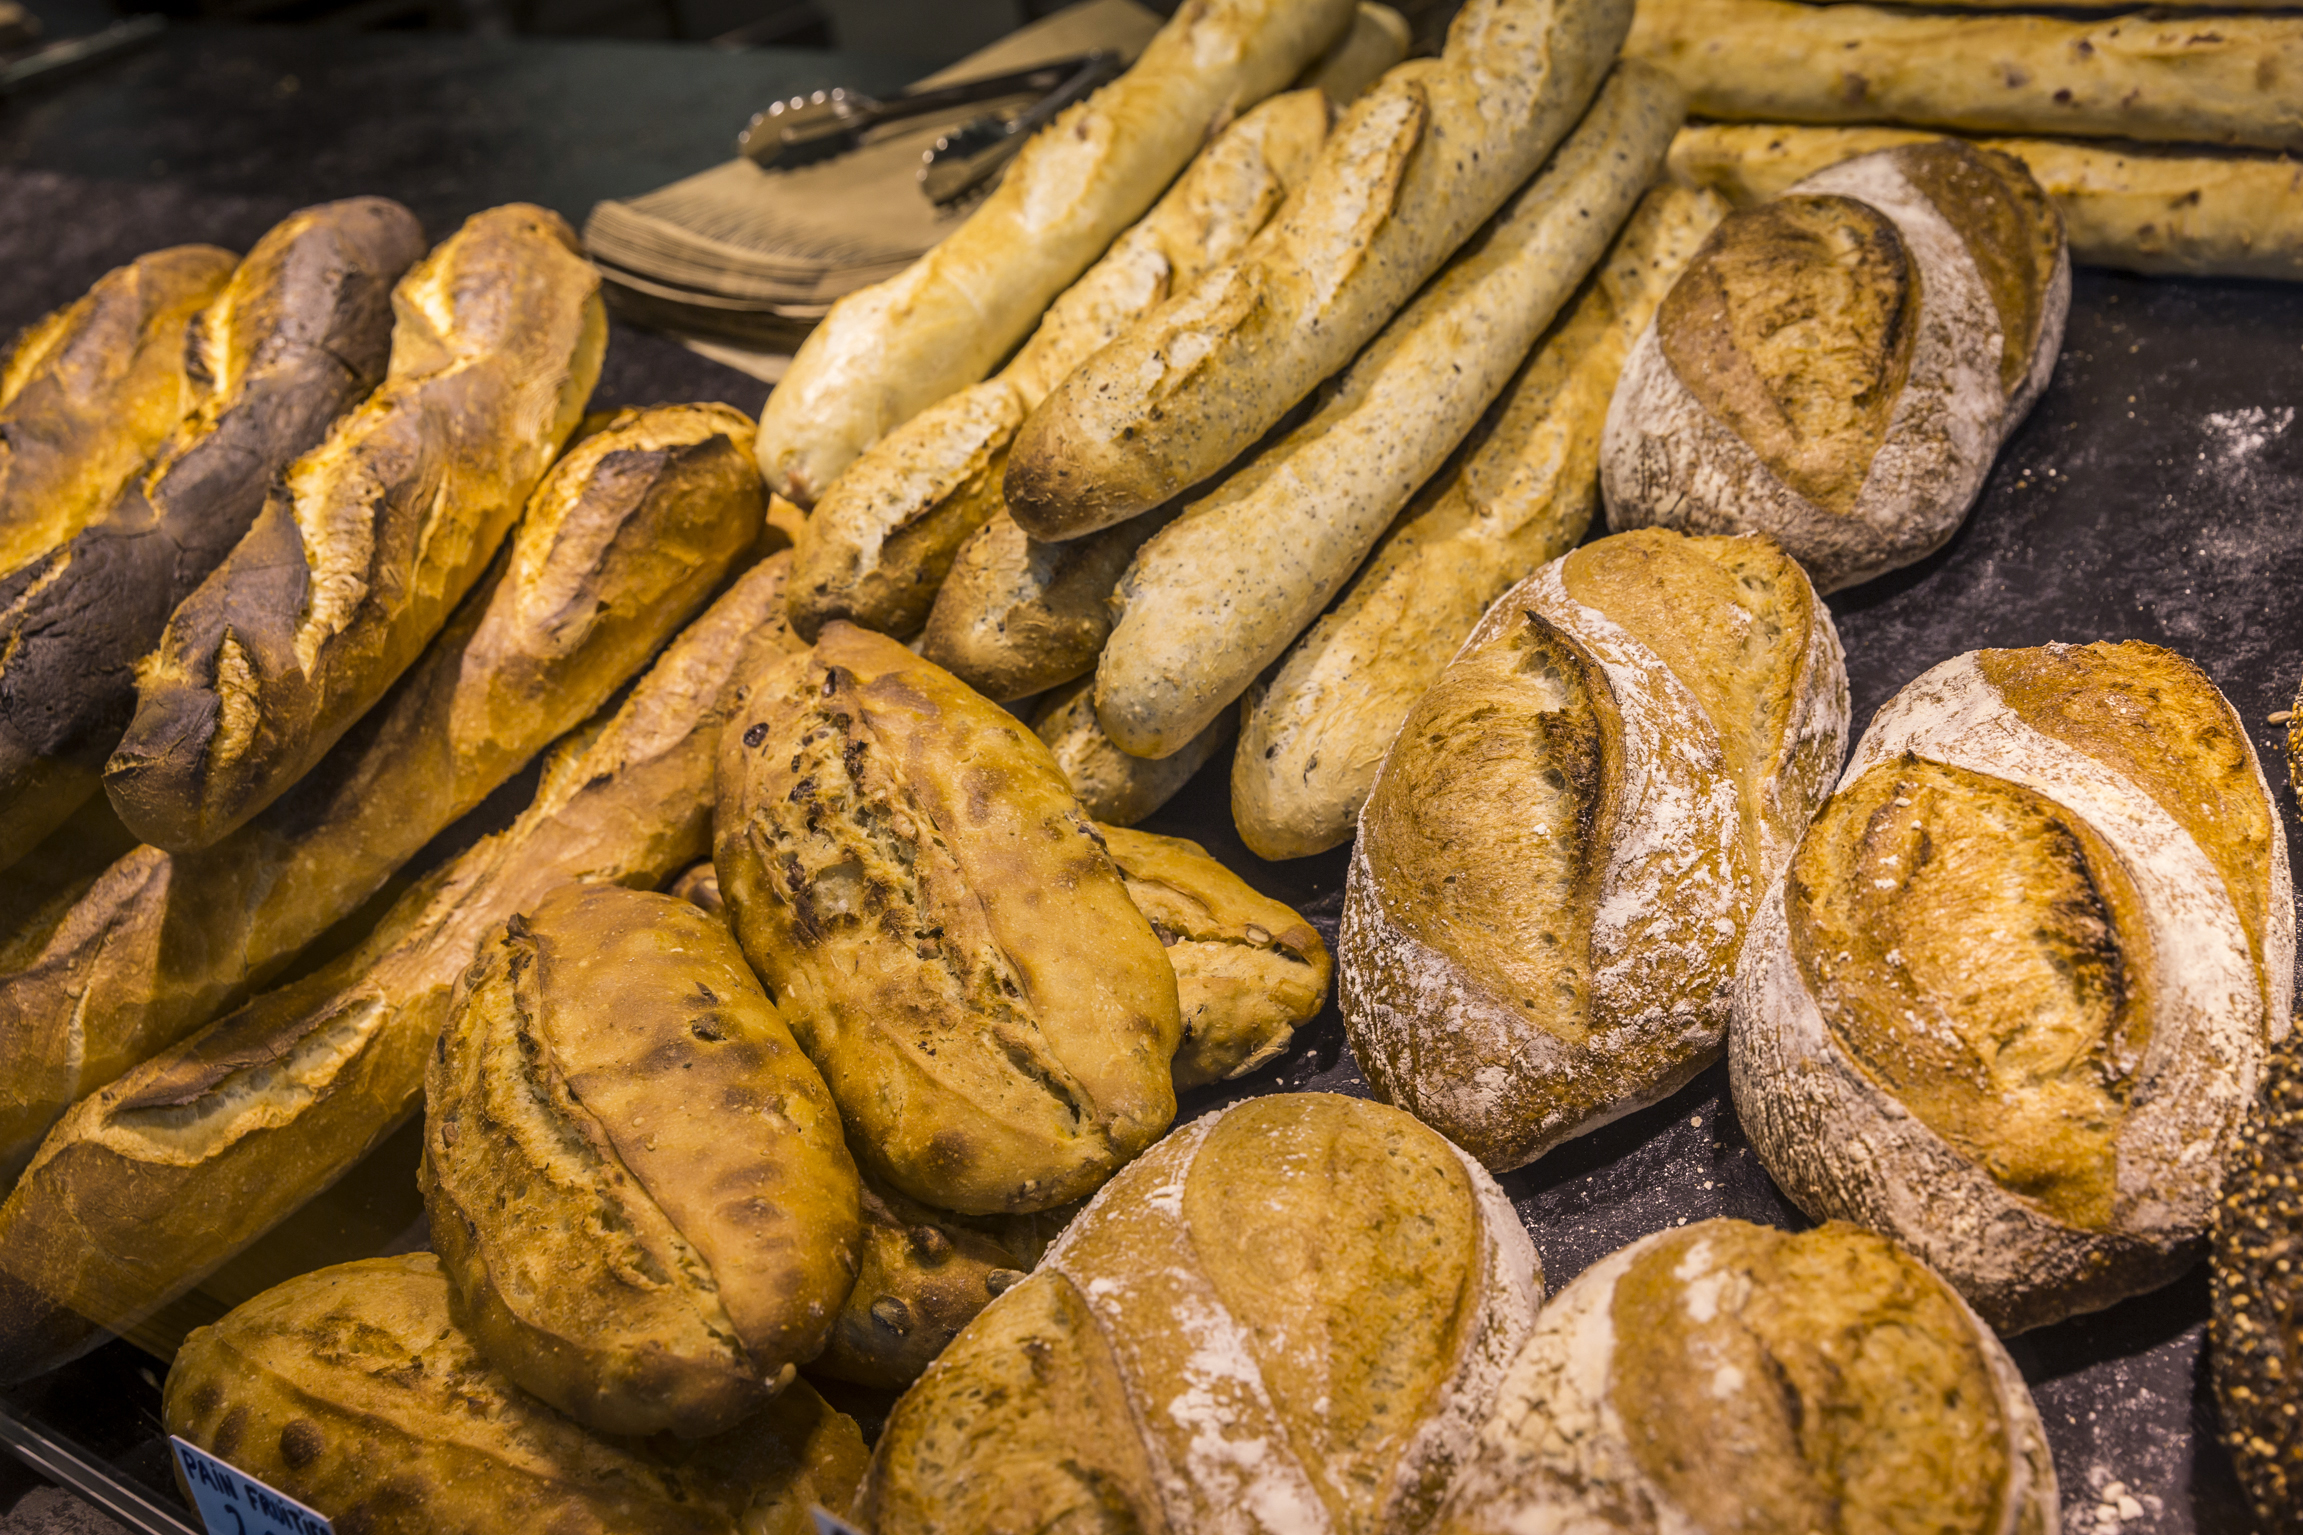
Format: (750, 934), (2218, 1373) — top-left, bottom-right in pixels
(419, 884), (861, 1438)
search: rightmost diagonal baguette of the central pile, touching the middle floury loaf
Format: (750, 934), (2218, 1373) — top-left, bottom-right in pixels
(1232, 184), (1725, 858)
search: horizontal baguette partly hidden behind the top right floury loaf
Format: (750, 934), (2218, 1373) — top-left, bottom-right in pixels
(1670, 122), (2303, 283)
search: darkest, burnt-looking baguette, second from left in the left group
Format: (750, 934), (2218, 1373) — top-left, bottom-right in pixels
(0, 198), (424, 874)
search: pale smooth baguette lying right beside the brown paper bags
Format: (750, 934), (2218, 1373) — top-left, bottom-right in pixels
(760, 0), (1354, 506)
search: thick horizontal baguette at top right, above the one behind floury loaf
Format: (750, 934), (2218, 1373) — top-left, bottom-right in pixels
(1624, 0), (2303, 150)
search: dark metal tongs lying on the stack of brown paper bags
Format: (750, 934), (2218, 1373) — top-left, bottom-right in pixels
(735, 48), (1122, 203)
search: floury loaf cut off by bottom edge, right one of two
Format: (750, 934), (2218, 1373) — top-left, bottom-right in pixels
(1428, 1220), (2061, 1535)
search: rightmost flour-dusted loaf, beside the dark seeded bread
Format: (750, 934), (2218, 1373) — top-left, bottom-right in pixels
(1730, 642), (2296, 1332)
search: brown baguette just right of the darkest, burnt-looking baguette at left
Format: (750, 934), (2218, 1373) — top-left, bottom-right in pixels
(104, 203), (608, 851)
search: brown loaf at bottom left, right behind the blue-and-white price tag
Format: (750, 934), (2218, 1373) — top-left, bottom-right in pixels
(161, 1252), (866, 1535)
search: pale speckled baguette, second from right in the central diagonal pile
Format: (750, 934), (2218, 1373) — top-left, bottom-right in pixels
(1076, 64), (1681, 757)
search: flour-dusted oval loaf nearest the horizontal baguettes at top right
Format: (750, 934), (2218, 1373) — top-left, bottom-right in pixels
(1601, 138), (2070, 591)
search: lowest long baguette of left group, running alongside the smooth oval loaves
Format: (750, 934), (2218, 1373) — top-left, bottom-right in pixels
(0, 555), (790, 1379)
